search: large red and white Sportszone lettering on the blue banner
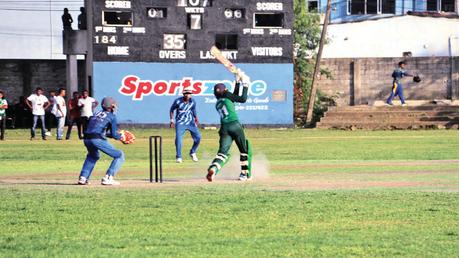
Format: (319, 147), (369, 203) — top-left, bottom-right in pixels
(118, 75), (268, 101)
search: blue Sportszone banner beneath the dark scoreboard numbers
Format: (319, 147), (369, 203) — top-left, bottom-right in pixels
(93, 62), (293, 125)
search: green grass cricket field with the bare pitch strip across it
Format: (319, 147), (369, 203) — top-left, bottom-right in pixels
(0, 129), (459, 257)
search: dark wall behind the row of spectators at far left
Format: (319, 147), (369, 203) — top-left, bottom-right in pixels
(0, 60), (85, 103)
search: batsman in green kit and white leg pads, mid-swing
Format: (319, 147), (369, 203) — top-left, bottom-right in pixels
(206, 70), (252, 182)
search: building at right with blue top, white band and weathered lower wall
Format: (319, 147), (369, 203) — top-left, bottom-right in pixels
(308, 0), (459, 105)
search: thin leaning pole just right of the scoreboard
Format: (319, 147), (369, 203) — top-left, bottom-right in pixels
(306, 0), (331, 126)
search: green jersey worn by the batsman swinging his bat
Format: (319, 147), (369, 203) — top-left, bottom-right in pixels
(215, 83), (248, 124)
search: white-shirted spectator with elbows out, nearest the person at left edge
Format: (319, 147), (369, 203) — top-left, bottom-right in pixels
(25, 87), (49, 140)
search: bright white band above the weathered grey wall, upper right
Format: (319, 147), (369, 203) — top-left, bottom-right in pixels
(323, 15), (459, 58)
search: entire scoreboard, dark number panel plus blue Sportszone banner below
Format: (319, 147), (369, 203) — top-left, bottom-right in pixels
(92, 0), (293, 125)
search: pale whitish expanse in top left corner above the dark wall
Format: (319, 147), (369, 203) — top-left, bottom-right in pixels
(0, 0), (84, 59)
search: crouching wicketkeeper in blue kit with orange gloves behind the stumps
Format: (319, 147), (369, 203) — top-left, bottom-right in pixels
(78, 97), (135, 185)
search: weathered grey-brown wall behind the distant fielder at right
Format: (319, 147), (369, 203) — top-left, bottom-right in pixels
(319, 57), (459, 105)
